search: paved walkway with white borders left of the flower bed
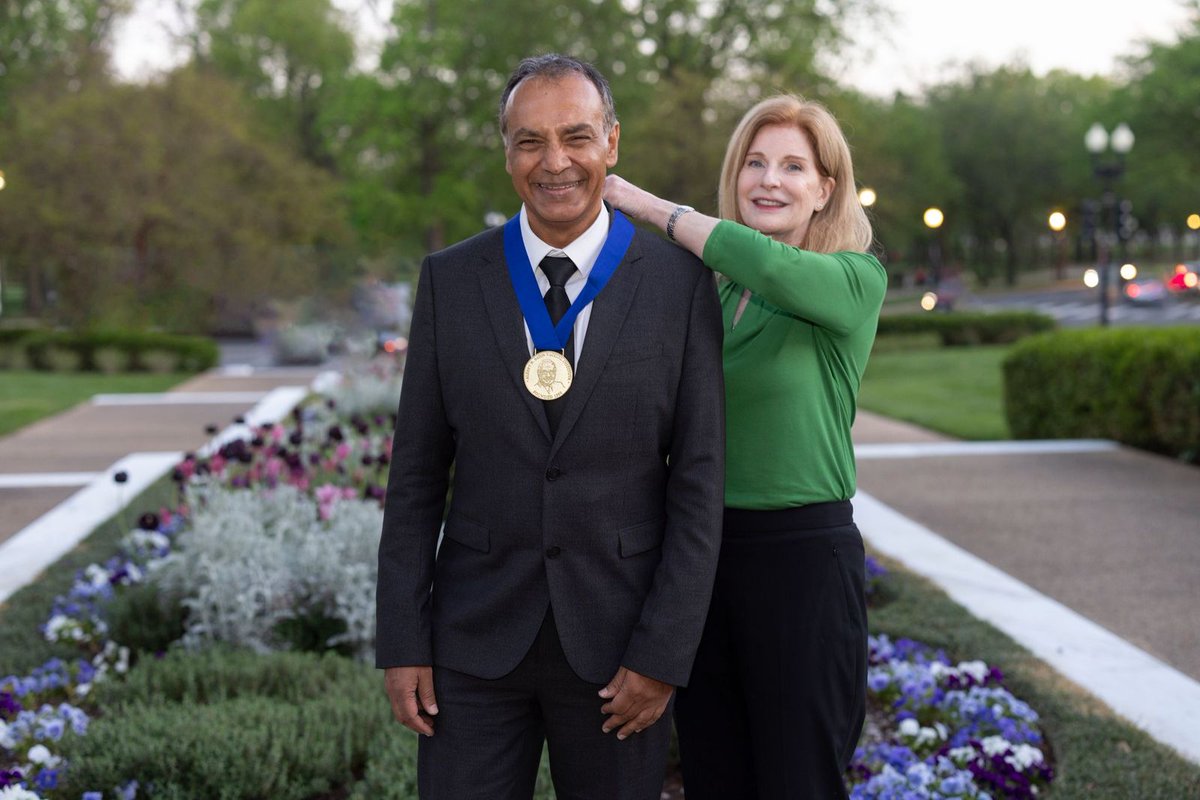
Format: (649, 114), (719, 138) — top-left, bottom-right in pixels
(0, 366), (318, 603)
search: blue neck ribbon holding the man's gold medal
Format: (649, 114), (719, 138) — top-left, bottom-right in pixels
(504, 209), (634, 350)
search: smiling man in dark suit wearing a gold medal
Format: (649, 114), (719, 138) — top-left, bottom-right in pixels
(376, 55), (725, 800)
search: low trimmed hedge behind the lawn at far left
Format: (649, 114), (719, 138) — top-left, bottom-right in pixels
(0, 329), (220, 372)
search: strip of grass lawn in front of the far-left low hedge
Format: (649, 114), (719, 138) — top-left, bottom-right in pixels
(0, 369), (191, 437)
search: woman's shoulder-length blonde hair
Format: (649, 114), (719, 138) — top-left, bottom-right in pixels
(718, 95), (872, 253)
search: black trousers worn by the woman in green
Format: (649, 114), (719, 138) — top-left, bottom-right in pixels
(676, 501), (866, 800)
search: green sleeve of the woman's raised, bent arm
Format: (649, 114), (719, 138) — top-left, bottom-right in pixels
(704, 219), (888, 336)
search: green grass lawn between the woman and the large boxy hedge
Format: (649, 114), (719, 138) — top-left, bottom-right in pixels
(858, 338), (1009, 439)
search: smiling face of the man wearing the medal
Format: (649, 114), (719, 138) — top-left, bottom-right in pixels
(504, 74), (620, 247)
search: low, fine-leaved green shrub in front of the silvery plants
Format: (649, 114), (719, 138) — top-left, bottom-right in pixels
(62, 650), (393, 800)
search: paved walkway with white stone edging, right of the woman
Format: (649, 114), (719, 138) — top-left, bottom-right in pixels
(854, 414), (1200, 763)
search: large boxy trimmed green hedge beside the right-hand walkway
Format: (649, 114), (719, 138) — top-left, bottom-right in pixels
(1003, 327), (1200, 463)
